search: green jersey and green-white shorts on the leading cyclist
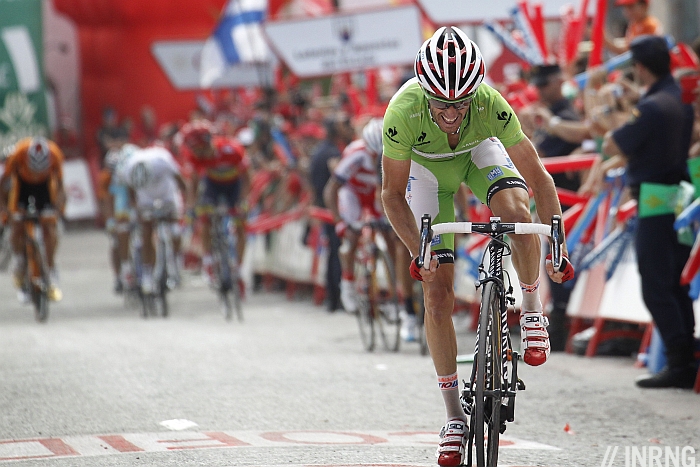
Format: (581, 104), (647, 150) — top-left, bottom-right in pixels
(382, 79), (527, 252)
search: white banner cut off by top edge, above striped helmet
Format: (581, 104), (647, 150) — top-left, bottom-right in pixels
(418, 0), (595, 25)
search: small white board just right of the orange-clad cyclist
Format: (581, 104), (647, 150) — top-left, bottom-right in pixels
(63, 159), (97, 220)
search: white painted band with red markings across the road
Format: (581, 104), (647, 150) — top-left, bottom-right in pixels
(0, 431), (559, 465)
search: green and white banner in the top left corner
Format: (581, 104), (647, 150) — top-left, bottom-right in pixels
(0, 0), (48, 151)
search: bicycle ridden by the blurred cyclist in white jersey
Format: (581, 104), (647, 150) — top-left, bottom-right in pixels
(134, 200), (179, 318)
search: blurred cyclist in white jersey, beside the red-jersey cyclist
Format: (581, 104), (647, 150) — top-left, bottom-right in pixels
(118, 146), (189, 293)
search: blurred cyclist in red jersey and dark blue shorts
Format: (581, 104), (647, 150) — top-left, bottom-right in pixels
(179, 120), (250, 284)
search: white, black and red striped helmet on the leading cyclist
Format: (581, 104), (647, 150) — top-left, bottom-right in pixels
(413, 26), (484, 101)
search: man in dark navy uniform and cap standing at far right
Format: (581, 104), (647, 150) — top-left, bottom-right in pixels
(594, 35), (696, 388)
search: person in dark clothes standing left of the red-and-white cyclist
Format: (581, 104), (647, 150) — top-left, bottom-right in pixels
(309, 114), (353, 312)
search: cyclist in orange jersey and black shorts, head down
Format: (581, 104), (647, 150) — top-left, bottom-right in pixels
(0, 136), (66, 302)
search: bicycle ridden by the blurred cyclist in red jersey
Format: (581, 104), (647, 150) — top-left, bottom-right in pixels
(210, 205), (243, 322)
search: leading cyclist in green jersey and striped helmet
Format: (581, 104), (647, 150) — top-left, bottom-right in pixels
(382, 27), (574, 466)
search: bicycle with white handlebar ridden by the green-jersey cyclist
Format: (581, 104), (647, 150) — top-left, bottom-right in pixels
(418, 214), (563, 467)
